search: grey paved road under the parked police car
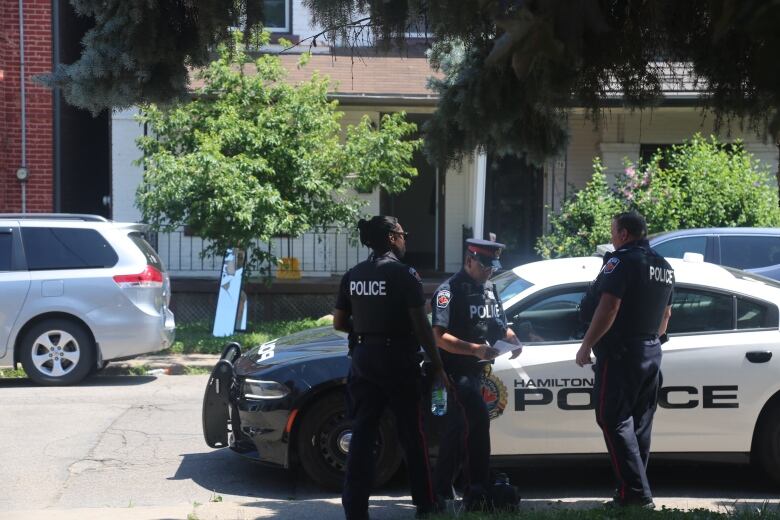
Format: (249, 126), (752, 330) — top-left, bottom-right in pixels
(0, 376), (780, 520)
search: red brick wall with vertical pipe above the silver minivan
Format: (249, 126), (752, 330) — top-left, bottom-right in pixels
(0, 0), (54, 212)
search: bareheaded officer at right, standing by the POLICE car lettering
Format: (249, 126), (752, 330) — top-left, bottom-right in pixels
(576, 212), (674, 509)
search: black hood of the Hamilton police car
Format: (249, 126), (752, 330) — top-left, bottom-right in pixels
(235, 327), (347, 375)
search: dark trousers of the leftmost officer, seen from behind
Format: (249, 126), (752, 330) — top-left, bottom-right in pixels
(341, 344), (434, 520)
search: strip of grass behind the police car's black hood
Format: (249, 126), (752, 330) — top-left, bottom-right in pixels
(168, 318), (330, 354)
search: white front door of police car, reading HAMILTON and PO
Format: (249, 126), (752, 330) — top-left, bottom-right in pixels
(491, 283), (604, 455)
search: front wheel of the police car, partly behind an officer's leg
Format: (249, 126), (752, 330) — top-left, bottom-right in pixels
(298, 392), (401, 490)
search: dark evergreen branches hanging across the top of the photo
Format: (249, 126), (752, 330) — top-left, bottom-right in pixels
(50, 0), (780, 167)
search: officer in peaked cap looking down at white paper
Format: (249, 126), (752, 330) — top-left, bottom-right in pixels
(431, 239), (522, 508)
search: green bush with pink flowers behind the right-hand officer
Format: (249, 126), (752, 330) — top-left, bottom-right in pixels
(536, 134), (780, 258)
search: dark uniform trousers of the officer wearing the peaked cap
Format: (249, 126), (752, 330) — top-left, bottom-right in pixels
(433, 374), (490, 498)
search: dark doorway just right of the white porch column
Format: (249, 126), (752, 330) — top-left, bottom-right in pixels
(484, 156), (544, 269)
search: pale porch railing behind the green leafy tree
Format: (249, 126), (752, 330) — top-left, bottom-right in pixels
(150, 228), (369, 277)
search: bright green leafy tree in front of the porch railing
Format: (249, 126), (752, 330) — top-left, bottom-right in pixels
(137, 35), (420, 269)
